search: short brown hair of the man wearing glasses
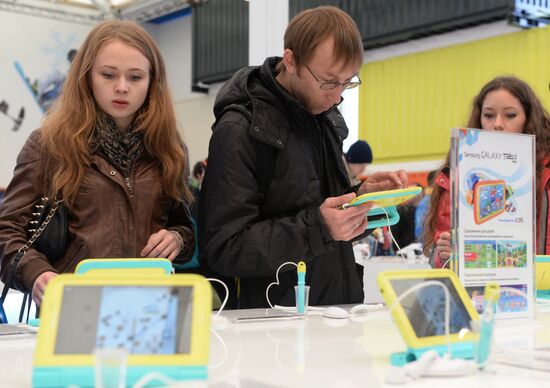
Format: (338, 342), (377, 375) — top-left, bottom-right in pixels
(279, 6), (363, 70)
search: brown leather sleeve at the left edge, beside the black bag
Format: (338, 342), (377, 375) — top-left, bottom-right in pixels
(0, 131), (56, 291)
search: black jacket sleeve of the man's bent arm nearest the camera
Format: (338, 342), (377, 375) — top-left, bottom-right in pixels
(199, 118), (334, 277)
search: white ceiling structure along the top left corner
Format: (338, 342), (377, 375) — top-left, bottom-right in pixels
(0, 0), (193, 24)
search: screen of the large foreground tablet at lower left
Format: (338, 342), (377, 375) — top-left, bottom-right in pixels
(55, 286), (193, 355)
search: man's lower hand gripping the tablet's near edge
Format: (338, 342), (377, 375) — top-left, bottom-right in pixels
(319, 193), (372, 241)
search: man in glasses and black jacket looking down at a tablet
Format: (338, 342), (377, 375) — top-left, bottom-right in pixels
(199, 6), (407, 308)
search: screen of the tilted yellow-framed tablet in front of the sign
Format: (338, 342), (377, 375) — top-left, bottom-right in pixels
(390, 278), (471, 338)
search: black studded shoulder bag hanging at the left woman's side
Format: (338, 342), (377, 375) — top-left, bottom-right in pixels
(0, 197), (67, 322)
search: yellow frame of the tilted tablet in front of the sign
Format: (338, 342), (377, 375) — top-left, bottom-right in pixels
(377, 269), (479, 349)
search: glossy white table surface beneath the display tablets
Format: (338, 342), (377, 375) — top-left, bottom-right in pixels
(0, 308), (550, 388)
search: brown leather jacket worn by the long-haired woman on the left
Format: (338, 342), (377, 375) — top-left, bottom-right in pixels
(0, 130), (194, 291)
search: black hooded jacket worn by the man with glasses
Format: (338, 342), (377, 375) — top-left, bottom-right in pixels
(199, 57), (363, 308)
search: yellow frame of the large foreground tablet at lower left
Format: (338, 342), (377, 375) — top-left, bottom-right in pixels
(33, 271), (212, 368)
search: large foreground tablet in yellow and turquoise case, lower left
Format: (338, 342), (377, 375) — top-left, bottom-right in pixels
(32, 271), (212, 387)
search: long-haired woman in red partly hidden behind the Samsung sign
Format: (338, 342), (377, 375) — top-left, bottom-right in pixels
(424, 77), (550, 268)
